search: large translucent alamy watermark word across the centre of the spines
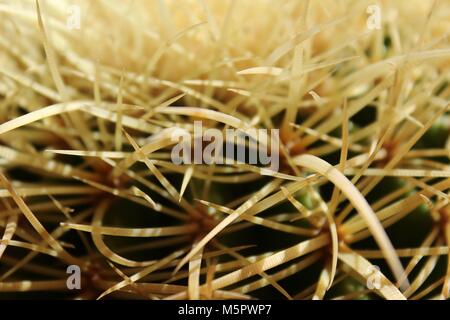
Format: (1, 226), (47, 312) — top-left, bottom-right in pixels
(171, 121), (280, 172)
